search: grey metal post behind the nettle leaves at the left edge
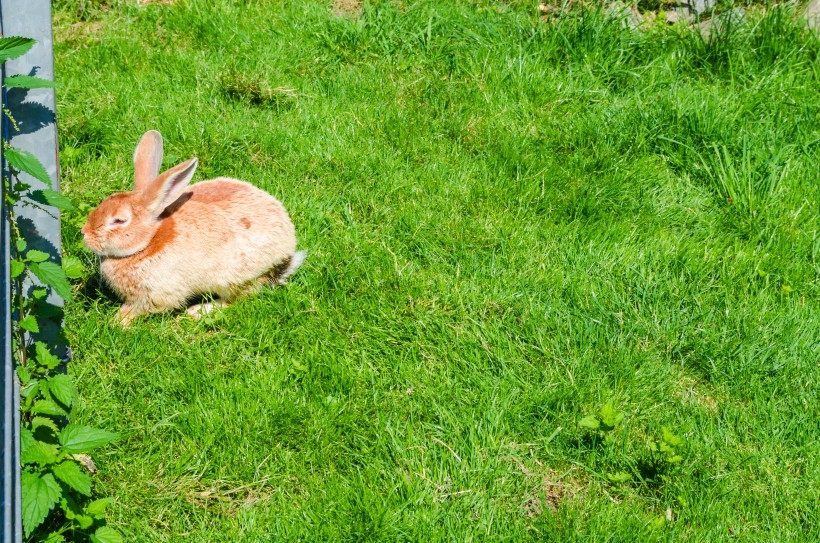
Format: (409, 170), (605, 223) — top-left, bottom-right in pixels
(0, 0), (60, 543)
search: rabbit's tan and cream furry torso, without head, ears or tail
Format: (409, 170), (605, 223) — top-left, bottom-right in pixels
(100, 178), (296, 311)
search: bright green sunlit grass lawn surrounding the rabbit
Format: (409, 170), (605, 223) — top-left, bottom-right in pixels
(55, 0), (820, 542)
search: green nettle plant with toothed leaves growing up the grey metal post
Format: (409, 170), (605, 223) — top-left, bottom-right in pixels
(0, 37), (123, 543)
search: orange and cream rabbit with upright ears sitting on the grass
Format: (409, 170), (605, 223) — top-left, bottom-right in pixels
(82, 130), (306, 326)
